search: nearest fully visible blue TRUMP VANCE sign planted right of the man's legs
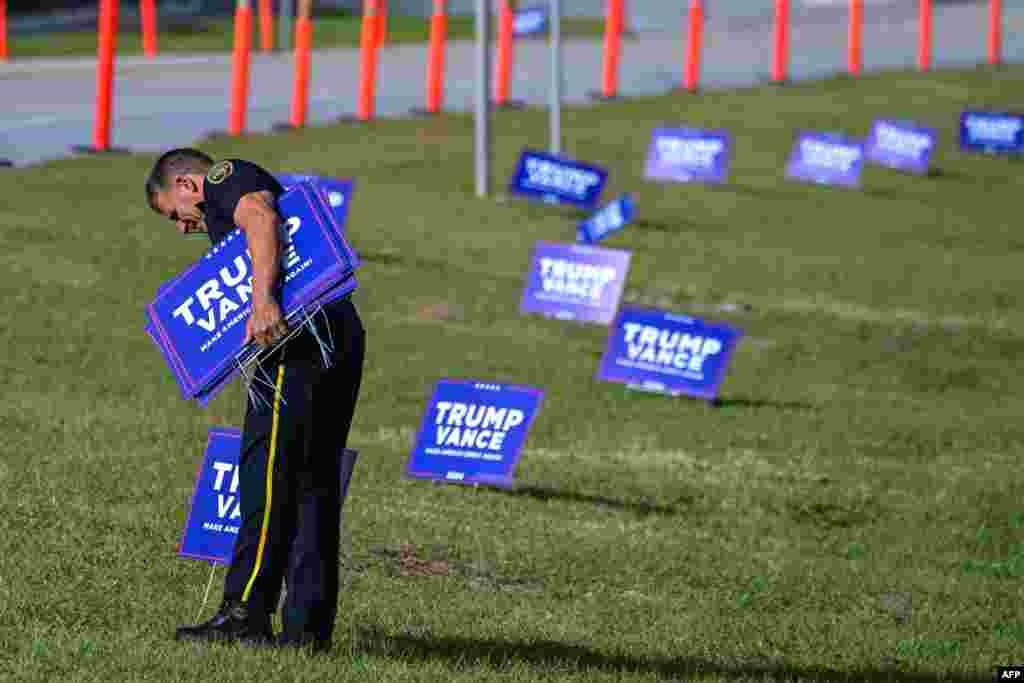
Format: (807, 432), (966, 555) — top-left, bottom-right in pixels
(406, 380), (544, 486)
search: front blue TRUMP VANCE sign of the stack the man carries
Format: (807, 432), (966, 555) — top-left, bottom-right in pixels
(146, 184), (358, 396)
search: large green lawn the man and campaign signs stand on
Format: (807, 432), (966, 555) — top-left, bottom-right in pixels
(0, 67), (1024, 683)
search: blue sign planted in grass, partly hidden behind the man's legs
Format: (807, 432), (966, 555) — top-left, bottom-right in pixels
(178, 427), (242, 564)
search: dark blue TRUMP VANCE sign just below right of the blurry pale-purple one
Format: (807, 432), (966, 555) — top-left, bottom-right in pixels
(597, 306), (743, 400)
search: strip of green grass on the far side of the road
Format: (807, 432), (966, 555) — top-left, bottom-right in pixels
(8, 12), (604, 59)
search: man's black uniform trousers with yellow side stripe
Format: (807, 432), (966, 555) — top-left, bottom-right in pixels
(224, 302), (365, 642)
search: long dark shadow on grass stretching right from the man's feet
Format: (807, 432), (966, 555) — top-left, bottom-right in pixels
(357, 627), (991, 683)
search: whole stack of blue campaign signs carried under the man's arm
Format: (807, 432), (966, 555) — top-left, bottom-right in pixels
(145, 176), (359, 407)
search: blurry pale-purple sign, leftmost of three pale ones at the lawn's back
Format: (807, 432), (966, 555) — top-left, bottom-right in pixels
(644, 128), (730, 183)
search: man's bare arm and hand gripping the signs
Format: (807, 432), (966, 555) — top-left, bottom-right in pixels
(234, 190), (288, 346)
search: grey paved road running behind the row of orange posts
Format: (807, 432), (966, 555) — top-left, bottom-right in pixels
(0, 3), (1024, 166)
